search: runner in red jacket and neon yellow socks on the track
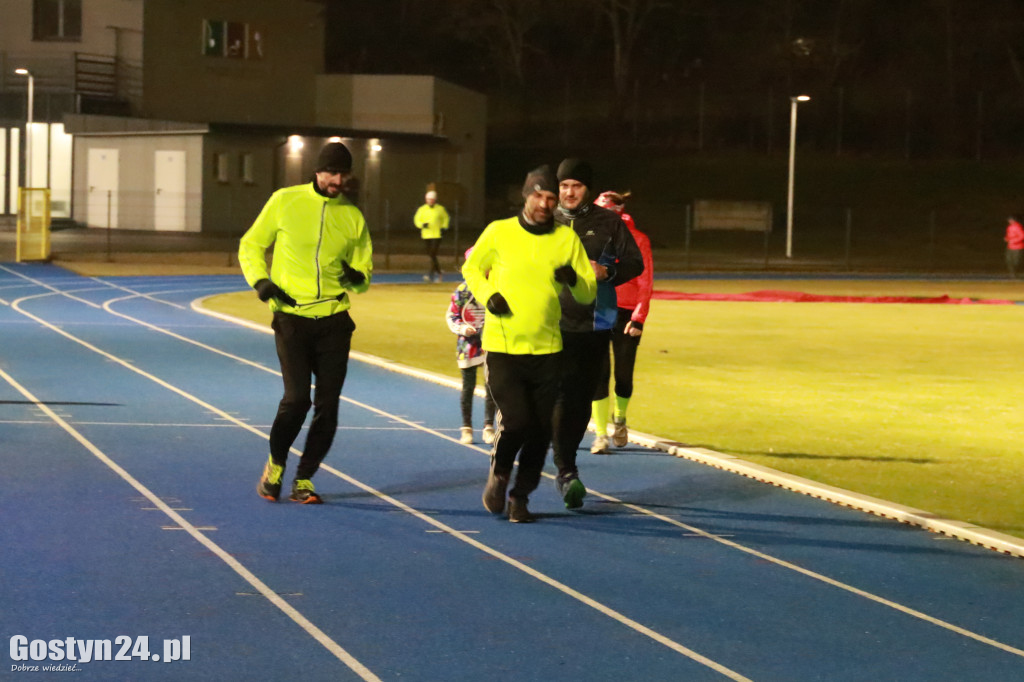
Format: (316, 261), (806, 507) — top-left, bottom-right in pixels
(590, 191), (654, 448)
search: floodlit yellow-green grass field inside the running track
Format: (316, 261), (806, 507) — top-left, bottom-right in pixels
(209, 280), (1024, 538)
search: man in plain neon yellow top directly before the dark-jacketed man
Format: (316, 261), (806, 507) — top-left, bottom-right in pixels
(462, 166), (597, 522)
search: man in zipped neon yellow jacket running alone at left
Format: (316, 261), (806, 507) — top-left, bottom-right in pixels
(239, 142), (373, 504)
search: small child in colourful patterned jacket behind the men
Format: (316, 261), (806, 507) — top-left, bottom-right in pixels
(445, 248), (495, 445)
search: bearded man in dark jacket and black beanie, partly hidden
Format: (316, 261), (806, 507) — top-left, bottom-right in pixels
(552, 159), (643, 509)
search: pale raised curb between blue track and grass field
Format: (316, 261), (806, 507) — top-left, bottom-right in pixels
(191, 297), (1024, 558)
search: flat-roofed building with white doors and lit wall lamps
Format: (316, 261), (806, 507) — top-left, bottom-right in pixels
(0, 0), (486, 235)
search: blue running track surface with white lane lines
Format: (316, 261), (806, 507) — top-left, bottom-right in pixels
(0, 261), (1024, 680)
